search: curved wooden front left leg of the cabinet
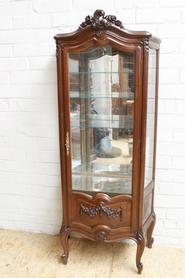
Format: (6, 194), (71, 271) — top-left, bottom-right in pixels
(60, 224), (70, 265)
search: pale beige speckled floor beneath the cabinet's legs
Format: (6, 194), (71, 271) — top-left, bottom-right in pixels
(0, 230), (185, 278)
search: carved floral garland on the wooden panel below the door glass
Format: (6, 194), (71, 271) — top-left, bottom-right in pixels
(80, 204), (122, 218)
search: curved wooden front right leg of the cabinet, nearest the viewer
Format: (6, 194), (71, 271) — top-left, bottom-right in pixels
(136, 233), (145, 274)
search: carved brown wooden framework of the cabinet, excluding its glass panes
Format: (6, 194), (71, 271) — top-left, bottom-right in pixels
(55, 10), (160, 273)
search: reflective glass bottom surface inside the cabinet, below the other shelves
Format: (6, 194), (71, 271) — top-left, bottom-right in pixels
(72, 163), (132, 194)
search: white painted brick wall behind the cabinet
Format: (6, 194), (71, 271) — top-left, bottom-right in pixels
(0, 0), (185, 246)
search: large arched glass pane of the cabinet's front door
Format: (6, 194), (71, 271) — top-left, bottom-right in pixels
(69, 46), (134, 194)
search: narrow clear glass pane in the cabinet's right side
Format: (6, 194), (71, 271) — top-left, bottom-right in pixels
(144, 49), (156, 187)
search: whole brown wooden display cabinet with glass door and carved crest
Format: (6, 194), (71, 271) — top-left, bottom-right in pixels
(55, 10), (160, 273)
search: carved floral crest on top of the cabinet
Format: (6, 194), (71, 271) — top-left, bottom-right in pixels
(79, 10), (123, 29)
